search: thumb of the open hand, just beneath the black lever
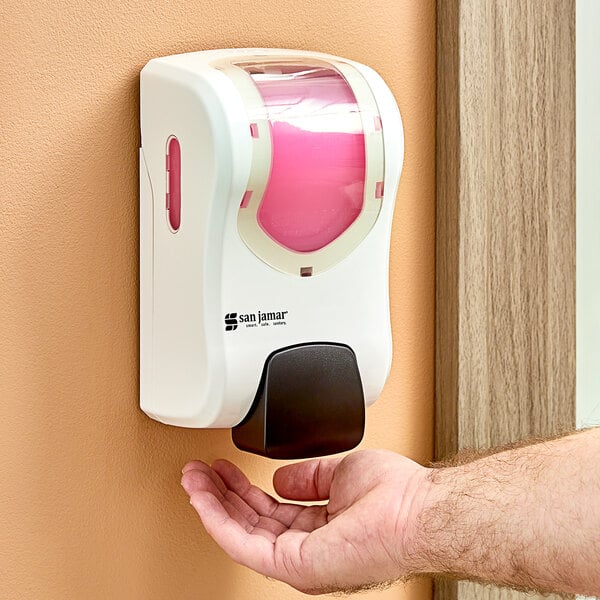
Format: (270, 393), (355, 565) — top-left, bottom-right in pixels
(273, 456), (345, 500)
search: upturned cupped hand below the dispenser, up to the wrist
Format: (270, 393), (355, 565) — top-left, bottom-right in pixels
(182, 450), (428, 594)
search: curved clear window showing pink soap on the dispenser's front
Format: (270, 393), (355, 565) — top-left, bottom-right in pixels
(247, 65), (366, 252)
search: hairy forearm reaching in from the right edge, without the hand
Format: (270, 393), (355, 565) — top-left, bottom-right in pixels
(413, 429), (600, 595)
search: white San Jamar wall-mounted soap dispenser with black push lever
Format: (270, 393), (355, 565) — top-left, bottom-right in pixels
(140, 49), (404, 458)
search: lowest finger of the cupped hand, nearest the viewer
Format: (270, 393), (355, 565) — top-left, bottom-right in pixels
(190, 491), (274, 576)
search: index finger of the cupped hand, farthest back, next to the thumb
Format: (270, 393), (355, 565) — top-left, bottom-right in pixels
(213, 459), (303, 526)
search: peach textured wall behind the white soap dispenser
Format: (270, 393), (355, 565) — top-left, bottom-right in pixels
(0, 0), (435, 600)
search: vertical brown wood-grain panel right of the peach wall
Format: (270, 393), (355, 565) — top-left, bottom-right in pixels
(435, 0), (575, 600)
